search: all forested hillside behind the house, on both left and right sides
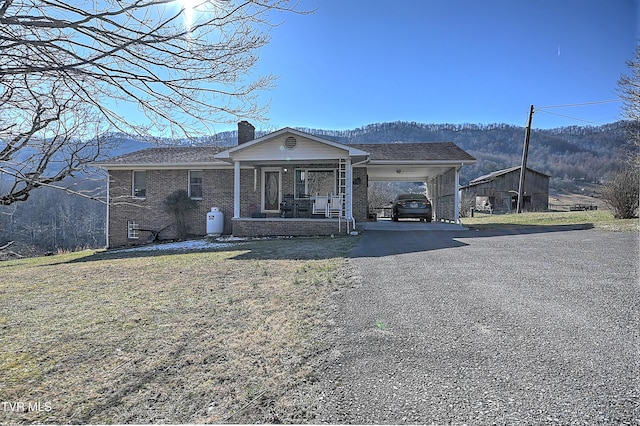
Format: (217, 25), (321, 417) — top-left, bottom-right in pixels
(0, 122), (626, 255)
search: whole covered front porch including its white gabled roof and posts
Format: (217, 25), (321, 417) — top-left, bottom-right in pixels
(216, 128), (367, 236)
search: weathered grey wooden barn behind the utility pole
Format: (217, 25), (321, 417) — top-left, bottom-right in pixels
(460, 166), (550, 213)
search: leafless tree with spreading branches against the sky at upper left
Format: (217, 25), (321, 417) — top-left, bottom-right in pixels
(0, 0), (296, 205)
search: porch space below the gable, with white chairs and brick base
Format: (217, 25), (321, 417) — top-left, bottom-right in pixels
(231, 159), (366, 236)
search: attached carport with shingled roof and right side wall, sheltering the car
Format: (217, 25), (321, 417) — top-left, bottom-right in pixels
(350, 142), (476, 223)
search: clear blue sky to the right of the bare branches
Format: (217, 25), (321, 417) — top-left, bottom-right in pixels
(229, 0), (640, 131)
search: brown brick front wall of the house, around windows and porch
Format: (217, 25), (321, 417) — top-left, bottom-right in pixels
(108, 164), (368, 247)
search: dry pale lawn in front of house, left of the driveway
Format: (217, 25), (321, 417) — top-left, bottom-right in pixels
(0, 237), (356, 423)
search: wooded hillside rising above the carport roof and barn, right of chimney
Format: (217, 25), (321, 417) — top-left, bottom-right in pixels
(302, 122), (626, 189)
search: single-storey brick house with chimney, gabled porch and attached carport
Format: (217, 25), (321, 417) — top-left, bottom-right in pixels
(95, 121), (475, 247)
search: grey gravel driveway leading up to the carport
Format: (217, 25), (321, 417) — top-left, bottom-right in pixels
(316, 227), (640, 424)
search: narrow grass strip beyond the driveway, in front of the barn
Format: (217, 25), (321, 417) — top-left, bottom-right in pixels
(462, 210), (640, 232)
